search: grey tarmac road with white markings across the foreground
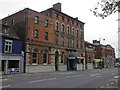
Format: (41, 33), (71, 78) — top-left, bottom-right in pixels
(2, 68), (119, 90)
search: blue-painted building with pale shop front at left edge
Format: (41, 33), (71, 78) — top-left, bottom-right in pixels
(0, 25), (23, 74)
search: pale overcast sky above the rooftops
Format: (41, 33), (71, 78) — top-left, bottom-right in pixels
(0, 0), (118, 57)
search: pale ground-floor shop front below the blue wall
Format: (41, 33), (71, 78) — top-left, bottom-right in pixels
(1, 55), (23, 74)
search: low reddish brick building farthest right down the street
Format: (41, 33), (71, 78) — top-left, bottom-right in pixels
(93, 40), (115, 67)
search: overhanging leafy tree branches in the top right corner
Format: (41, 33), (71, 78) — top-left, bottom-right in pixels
(91, 0), (120, 19)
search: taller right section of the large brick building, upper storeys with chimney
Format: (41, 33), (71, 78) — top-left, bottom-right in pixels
(41, 3), (84, 71)
